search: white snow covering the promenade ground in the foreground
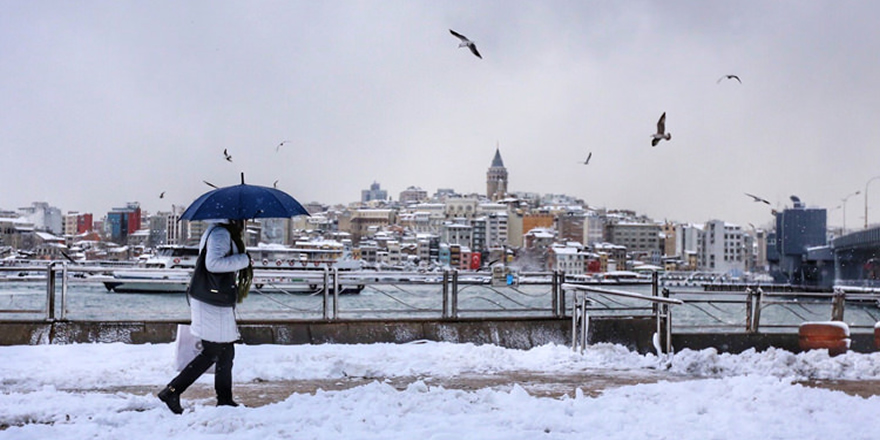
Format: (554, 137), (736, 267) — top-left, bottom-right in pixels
(0, 342), (880, 440)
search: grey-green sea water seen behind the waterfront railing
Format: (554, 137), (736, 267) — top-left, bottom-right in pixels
(0, 281), (880, 332)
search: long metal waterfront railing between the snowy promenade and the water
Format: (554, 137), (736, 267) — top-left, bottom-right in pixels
(0, 262), (880, 340)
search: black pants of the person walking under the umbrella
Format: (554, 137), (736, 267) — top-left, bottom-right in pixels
(168, 341), (235, 402)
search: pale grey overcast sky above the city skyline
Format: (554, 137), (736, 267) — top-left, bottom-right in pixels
(0, 0), (880, 228)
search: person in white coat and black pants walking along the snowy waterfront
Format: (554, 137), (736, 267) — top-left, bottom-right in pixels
(158, 220), (253, 414)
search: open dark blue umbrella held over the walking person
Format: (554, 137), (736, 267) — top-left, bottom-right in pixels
(180, 173), (309, 220)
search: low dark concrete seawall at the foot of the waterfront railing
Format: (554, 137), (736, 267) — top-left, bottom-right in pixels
(0, 318), (877, 353)
